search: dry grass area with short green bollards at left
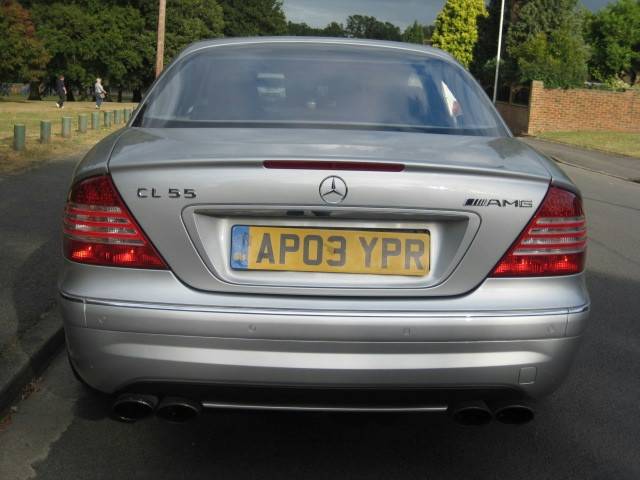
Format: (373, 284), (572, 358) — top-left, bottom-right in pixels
(0, 97), (136, 175)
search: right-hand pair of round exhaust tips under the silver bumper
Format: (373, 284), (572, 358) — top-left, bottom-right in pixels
(450, 400), (535, 426)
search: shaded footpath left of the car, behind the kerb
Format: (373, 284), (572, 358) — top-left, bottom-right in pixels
(0, 157), (78, 408)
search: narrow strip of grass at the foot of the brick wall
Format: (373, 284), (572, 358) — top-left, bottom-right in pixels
(538, 131), (640, 158)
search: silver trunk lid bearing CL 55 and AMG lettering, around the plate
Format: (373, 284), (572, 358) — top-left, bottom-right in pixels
(109, 128), (550, 296)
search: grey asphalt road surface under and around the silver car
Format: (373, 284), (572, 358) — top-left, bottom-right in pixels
(0, 159), (640, 480)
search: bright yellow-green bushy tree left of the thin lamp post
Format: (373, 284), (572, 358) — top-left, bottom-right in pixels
(506, 0), (589, 88)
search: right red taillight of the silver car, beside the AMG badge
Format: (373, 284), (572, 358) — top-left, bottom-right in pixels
(491, 187), (587, 277)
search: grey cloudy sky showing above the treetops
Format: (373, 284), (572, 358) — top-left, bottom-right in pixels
(284, 0), (610, 29)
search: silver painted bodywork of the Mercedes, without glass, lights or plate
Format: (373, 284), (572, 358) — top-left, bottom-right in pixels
(59, 38), (589, 409)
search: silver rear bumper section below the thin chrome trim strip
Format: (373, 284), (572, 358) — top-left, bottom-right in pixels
(60, 295), (588, 397)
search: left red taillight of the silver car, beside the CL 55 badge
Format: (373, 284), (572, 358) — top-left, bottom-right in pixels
(63, 175), (167, 269)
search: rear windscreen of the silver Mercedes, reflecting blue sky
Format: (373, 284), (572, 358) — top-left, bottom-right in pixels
(135, 43), (506, 136)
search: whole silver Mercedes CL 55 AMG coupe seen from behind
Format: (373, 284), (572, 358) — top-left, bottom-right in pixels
(59, 38), (589, 424)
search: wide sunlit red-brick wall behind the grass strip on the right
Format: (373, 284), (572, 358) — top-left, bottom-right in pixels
(524, 82), (640, 135)
